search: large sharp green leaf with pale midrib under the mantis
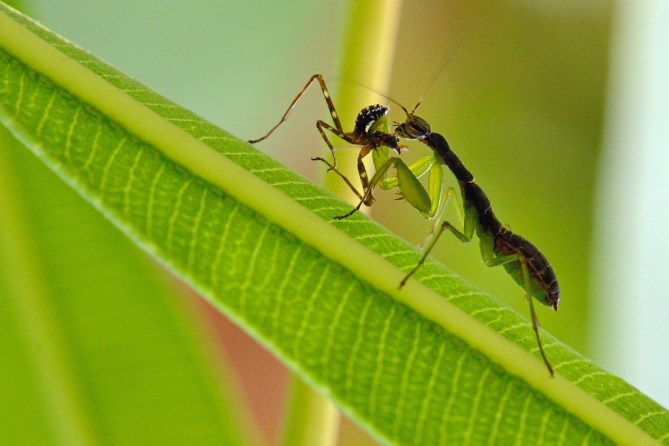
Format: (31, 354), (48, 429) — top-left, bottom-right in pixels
(0, 4), (669, 444)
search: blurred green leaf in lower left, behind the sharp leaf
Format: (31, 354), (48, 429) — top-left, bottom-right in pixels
(0, 124), (256, 445)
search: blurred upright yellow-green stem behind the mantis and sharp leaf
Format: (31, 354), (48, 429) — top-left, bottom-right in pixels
(284, 0), (402, 446)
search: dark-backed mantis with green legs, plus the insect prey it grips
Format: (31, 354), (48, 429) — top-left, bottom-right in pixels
(249, 74), (560, 376)
